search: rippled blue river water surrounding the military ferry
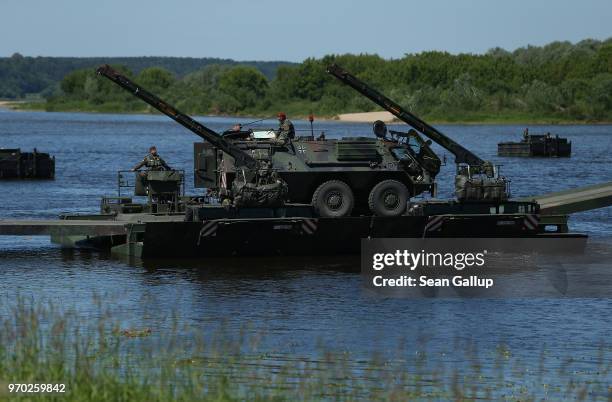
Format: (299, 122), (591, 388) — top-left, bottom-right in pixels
(0, 109), (612, 396)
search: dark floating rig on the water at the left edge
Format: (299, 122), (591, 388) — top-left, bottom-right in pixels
(0, 148), (55, 179)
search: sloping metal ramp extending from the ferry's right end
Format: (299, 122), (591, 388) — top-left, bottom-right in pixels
(518, 182), (612, 215)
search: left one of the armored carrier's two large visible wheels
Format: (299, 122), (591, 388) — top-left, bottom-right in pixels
(312, 180), (355, 218)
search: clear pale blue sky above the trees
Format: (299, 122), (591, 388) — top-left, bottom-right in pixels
(0, 0), (612, 61)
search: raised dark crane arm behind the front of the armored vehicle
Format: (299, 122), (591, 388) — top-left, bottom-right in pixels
(327, 64), (486, 167)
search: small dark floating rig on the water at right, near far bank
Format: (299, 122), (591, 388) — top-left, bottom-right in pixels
(497, 129), (572, 158)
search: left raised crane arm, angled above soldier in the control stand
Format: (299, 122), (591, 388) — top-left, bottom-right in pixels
(96, 65), (258, 169)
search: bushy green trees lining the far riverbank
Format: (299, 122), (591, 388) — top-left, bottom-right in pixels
(16, 38), (612, 121)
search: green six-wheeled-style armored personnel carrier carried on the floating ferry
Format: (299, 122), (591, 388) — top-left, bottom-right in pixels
(194, 127), (440, 217)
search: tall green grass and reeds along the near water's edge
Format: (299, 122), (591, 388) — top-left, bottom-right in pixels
(0, 300), (612, 401)
